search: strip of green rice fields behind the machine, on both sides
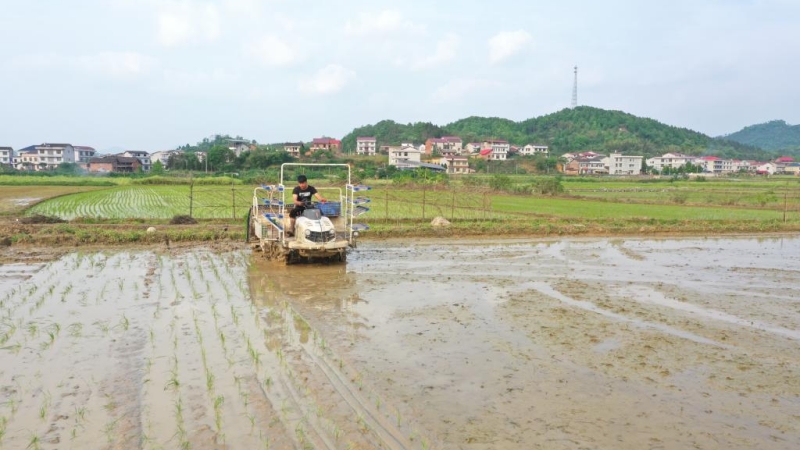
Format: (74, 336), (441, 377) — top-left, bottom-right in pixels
(18, 182), (800, 221)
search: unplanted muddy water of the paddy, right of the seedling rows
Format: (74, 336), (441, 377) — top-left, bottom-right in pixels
(251, 237), (800, 449)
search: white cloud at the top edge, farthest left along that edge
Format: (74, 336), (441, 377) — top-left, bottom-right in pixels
(157, 0), (222, 47)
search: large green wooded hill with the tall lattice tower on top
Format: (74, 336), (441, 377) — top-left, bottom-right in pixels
(342, 106), (775, 160)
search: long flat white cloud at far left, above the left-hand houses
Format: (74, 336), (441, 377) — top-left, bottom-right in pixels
(11, 52), (158, 79)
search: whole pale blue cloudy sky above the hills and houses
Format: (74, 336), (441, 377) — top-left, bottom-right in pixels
(0, 0), (800, 151)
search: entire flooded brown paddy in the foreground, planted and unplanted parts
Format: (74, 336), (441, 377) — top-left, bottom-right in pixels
(0, 237), (800, 449)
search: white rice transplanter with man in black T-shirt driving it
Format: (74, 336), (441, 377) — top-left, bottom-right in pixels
(248, 163), (370, 264)
